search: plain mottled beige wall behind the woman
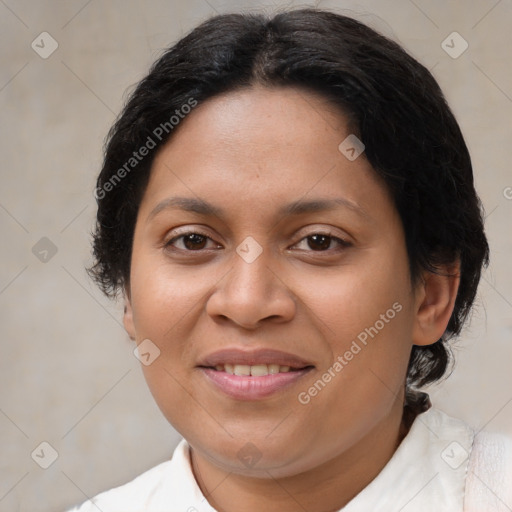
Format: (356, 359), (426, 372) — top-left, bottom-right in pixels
(0, 0), (512, 512)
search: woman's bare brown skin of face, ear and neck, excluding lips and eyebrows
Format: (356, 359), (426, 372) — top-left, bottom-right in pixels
(124, 87), (458, 512)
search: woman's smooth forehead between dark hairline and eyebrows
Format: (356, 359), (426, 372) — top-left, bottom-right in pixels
(141, 87), (389, 224)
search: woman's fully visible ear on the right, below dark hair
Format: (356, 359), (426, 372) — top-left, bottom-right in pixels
(413, 260), (460, 345)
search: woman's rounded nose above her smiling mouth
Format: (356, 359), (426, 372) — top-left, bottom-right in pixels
(206, 250), (296, 330)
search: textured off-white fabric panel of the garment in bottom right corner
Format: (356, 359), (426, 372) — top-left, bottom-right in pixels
(464, 431), (512, 512)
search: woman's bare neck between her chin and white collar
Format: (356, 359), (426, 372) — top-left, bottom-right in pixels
(191, 402), (412, 512)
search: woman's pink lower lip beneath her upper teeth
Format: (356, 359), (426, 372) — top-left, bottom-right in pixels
(201, 366), (312, 400)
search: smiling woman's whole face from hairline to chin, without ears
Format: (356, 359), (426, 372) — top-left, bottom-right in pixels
(125, 88), (433, 476)
